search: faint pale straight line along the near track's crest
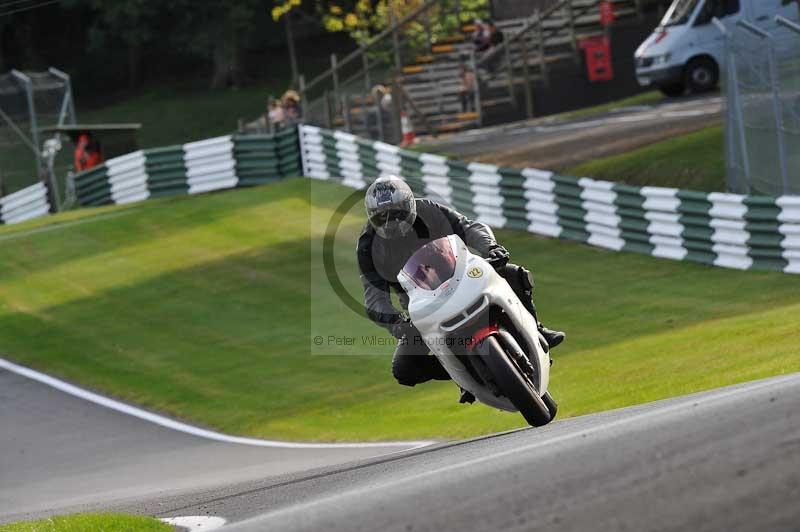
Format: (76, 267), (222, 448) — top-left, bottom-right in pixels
(228, 373), (800, 524)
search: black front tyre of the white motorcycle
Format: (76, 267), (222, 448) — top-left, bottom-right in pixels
(478, 336), (553, 427)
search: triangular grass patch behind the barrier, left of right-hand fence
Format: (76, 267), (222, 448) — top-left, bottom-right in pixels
(565, 126), (726, 192)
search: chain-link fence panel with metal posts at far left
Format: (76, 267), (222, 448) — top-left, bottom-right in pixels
(0, 68), (75, 196)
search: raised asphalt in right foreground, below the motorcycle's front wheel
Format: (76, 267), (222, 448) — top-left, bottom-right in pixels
(192, 374), (800, 532)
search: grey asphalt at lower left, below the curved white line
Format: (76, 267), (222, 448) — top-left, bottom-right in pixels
(0, 369), (424, 523)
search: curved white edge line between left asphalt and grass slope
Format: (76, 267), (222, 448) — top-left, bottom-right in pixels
(0, 358), (436, 450)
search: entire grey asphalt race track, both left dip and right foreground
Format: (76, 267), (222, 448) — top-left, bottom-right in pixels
(0, 360), (800, 532)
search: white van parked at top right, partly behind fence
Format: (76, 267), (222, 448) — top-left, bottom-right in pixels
(635, 0), (800, 96)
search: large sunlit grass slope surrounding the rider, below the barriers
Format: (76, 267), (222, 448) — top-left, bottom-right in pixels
(0, 179), (800, 441)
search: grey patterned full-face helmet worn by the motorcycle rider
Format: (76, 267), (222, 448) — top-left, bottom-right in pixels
(364, 175), (417, 238)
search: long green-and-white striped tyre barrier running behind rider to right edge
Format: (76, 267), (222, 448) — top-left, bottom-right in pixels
(300, 126), (800, 273)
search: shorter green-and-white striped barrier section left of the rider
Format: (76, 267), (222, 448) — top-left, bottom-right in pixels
(72, 129), (301, 206)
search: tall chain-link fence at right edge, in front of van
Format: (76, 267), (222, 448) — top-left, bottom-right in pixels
(724, 17), (800, 196)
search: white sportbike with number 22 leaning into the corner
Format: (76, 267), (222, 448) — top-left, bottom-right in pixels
(397, 235), (557, 427)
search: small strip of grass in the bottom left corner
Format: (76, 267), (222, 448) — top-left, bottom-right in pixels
(0, 514), (173, 532)
